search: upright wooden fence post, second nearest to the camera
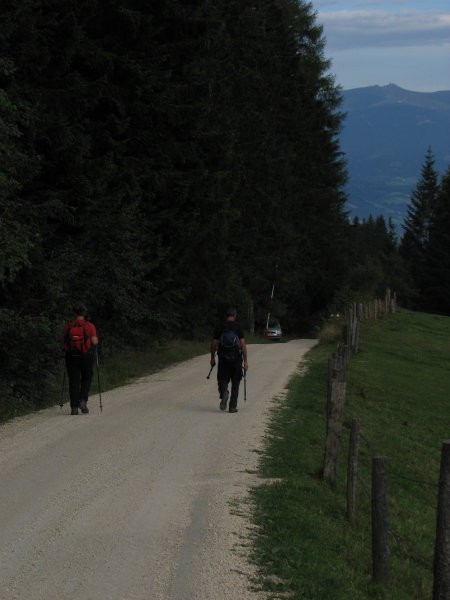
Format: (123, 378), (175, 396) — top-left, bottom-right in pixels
(372, 456), (390, 586)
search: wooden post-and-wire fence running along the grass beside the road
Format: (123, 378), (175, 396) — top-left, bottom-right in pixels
(323, 290), (450, 600)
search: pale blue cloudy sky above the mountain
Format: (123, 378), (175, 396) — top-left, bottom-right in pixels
(311, 0), (450, 92)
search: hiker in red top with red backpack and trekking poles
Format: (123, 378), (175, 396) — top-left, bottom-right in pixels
(62, 304), (98, 415)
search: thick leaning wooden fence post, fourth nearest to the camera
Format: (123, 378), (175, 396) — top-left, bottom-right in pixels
(323, 377), (346, 485)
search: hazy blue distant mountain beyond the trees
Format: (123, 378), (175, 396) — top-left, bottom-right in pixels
(340, 84), (450, 226)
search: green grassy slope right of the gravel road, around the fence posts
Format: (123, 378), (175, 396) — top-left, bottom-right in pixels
(252, 311), (450, 600)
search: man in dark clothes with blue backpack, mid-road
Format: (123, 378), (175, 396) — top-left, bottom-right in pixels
(211, 308), (248, 413)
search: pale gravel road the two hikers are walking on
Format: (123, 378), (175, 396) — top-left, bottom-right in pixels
(0, 340), (315, 600)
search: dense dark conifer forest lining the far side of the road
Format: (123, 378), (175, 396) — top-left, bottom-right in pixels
(0, 0), (449, 414)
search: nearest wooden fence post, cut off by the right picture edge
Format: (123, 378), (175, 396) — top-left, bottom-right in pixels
(433, 440), (450, 600)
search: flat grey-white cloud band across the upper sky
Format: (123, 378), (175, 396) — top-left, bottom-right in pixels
(318, 10), (450, 50)
